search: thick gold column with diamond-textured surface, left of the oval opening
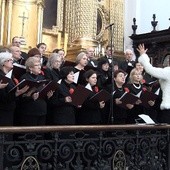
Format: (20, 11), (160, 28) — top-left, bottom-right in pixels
(65, 0), (97, 46)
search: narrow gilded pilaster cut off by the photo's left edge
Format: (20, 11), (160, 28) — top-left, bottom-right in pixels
(0, 0), (5, 45)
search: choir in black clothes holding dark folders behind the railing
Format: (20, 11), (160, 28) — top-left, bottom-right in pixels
(0, 37), (164, 126)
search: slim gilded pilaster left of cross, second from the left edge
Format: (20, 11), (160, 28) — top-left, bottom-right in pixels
(7, 0), (13, 44)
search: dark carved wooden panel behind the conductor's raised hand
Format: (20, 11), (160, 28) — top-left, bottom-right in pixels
(130, 29), (170, 66)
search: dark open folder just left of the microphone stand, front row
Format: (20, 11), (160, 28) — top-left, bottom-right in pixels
(90, 89), (111, 102)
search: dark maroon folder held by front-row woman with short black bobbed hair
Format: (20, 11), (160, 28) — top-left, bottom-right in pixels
(70, 85), (93, 107)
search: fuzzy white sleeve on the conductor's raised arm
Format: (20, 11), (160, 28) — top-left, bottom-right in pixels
(138, 54), (170, 79)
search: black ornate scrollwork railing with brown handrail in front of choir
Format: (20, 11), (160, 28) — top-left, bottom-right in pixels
(0, 125), (170, 170)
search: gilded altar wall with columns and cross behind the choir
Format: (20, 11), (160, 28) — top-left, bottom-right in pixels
(0, 0), (124, 60)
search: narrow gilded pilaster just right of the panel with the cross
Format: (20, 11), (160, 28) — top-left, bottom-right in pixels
(37, 0), (44, 44)
